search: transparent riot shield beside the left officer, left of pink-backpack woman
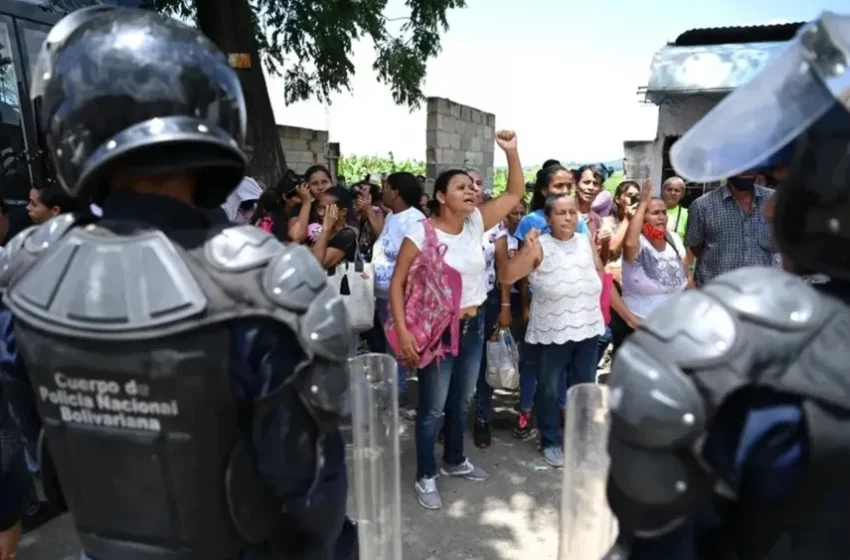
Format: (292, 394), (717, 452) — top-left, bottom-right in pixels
(348, 354), (401, 560)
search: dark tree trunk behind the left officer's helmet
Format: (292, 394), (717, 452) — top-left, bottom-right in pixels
(195, 0), (286, 187)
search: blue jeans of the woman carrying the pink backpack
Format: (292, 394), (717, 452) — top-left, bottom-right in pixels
(416, 314), (484, 480)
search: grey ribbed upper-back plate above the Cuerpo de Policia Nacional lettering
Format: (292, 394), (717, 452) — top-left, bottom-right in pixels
(6, 225), (207, 338)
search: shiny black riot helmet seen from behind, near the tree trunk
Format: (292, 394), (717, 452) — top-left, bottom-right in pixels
(31, 6), (247, 208)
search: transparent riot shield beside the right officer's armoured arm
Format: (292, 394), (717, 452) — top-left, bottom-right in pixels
(559, 383), (617, 560)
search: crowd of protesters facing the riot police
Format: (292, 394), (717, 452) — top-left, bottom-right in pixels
(151, 128), (778, 509)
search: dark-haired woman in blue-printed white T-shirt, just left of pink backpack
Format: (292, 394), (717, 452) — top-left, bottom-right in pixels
(372, 172), (425, 396)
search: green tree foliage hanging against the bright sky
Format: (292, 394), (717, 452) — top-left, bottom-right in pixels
(155, 0), (466, 109)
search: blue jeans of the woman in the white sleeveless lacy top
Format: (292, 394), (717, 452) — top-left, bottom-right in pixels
(534, 336), (599, 449)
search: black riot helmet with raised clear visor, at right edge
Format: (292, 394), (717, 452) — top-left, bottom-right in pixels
(670, 12), (850, 281)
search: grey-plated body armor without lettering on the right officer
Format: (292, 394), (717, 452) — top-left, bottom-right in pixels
(609, 268), (850, 560)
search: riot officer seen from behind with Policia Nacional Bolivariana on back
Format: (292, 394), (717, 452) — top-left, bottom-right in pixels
(0, 7), (353, 560)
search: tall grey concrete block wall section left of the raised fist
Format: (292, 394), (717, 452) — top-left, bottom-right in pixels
(425, 97), (496, 192)
